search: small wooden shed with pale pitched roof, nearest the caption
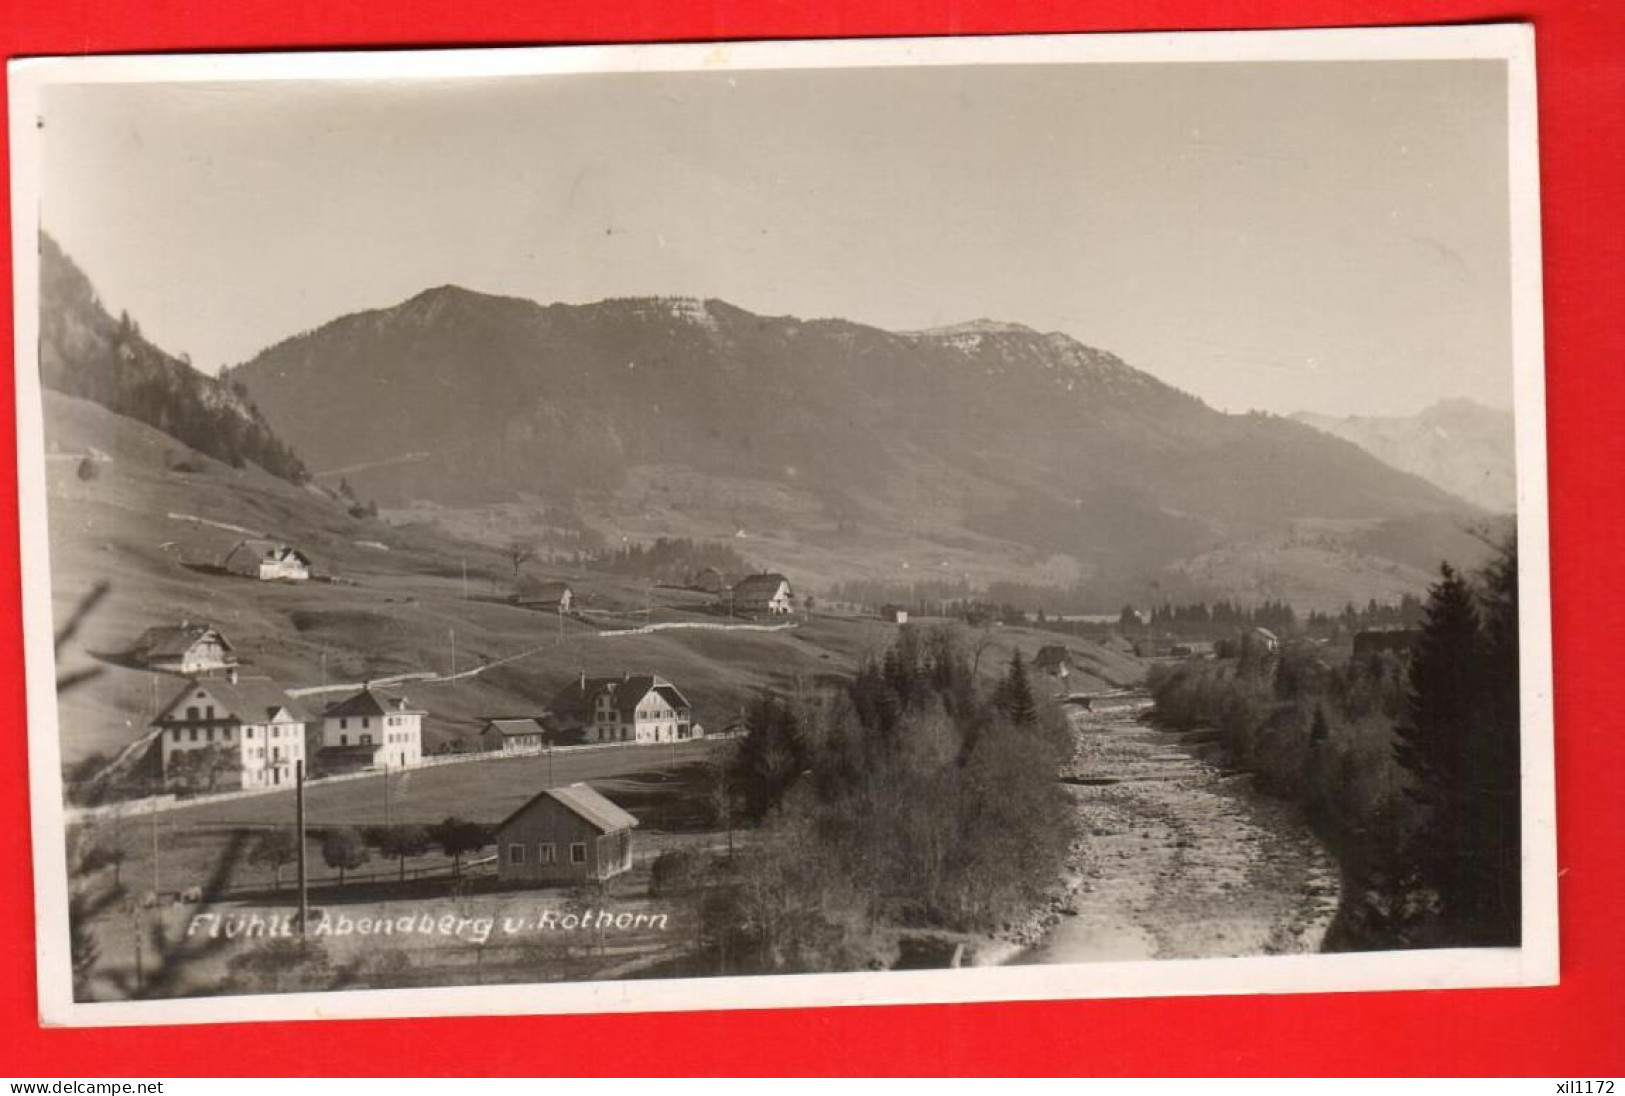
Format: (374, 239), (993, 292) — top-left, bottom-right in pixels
(496, 784), (637, 883)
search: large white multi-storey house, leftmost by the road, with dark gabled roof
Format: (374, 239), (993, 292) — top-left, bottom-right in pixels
(153, 678), (310, 792)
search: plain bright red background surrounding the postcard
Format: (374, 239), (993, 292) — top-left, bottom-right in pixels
(0, 0), (1625, 1076)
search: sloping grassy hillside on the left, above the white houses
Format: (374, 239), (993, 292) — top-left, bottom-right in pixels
(46, 392), (1141, 763)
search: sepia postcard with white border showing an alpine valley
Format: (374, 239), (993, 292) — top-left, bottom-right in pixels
(10, 26), (1557, 1024)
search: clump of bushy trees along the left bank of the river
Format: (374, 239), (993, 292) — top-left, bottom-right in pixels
(702, 629), (1074, 971)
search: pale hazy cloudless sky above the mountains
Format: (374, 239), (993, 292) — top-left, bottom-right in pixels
(42, 62), (1511, 413)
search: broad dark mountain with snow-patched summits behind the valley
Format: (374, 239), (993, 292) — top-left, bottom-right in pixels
(229, 285), (1477, 604)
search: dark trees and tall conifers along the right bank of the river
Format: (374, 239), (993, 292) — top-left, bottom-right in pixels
(1152, 543), (1521, 948)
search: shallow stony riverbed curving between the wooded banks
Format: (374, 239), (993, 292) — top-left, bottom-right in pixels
(1017, 707), (1339, 963)
